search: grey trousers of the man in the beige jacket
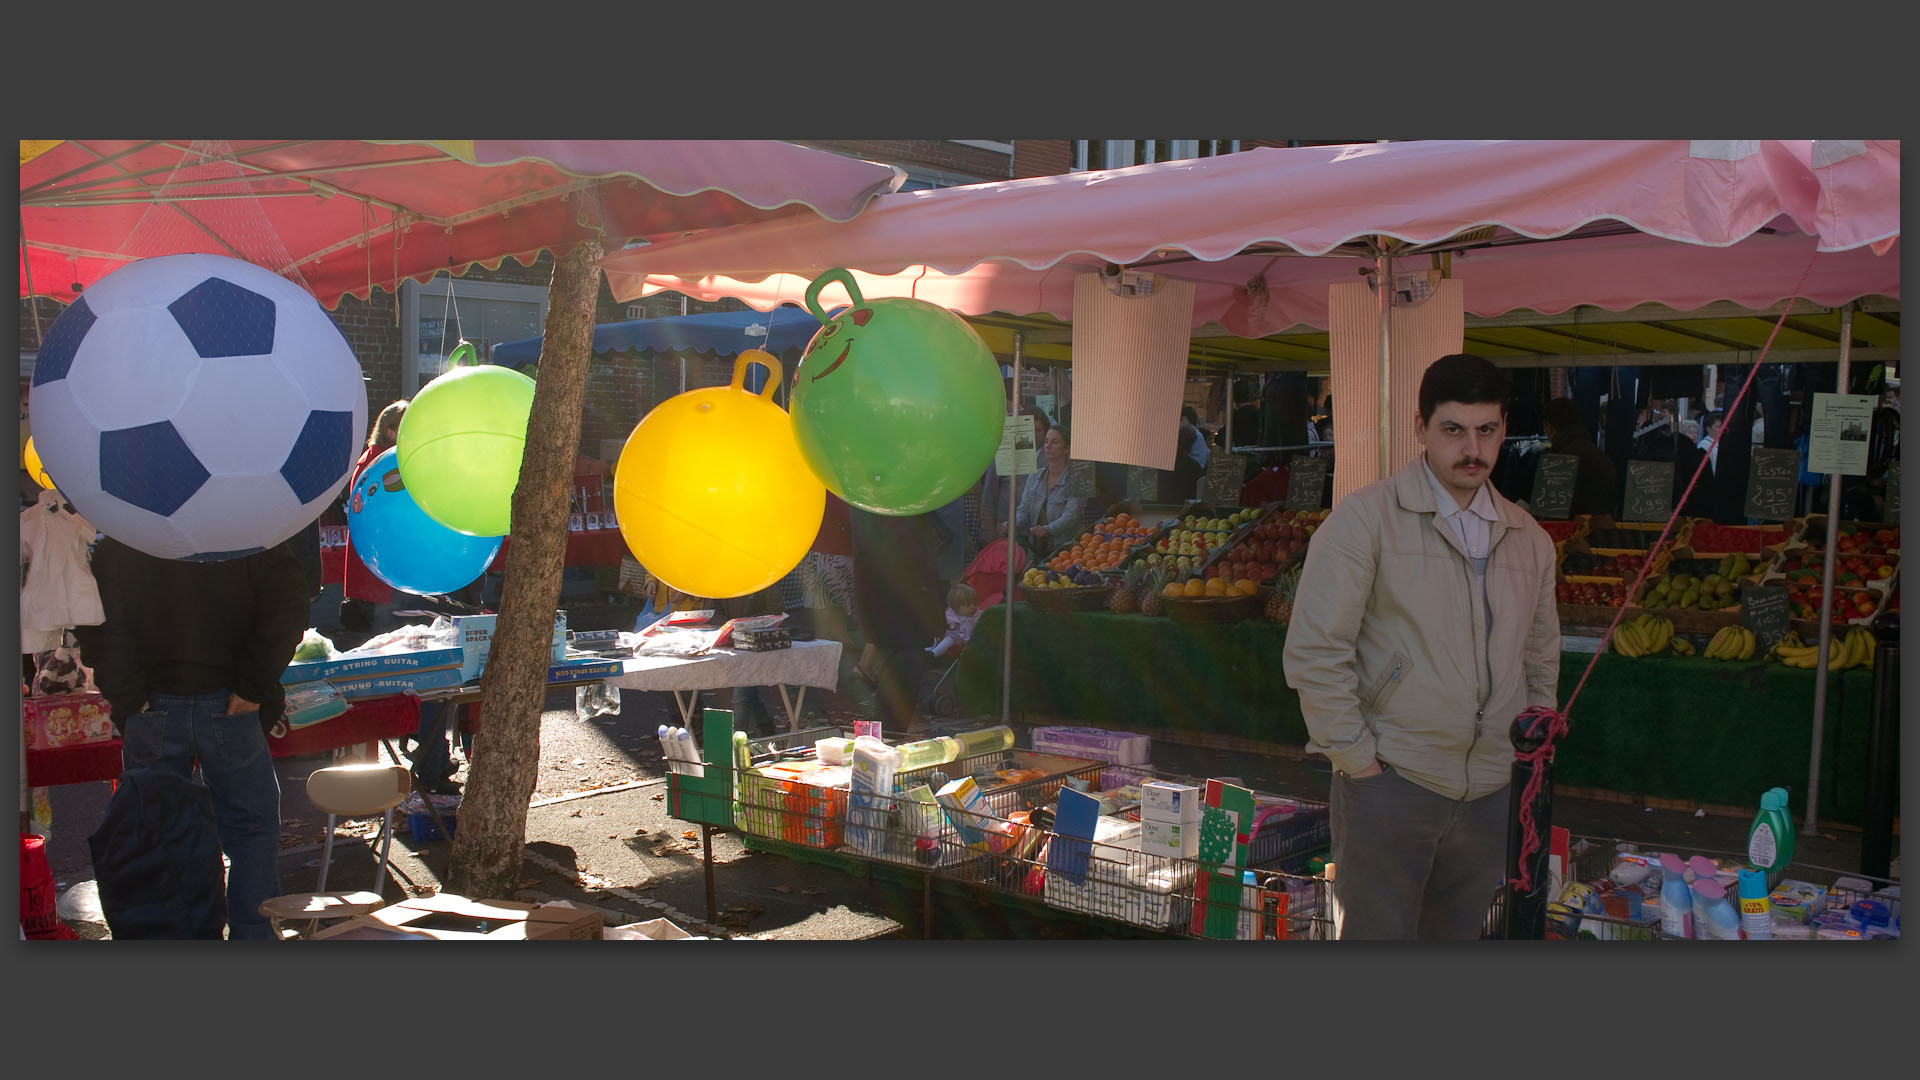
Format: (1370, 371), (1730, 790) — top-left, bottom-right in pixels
(1331, 767), (1507, 940)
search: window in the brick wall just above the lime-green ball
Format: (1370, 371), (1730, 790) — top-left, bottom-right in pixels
(399, 277), (547, 398)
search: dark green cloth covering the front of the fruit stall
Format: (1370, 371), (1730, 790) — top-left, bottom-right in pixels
(954, 603), (1874, 824)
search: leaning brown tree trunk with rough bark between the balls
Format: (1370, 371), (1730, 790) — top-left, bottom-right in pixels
(447, 240), (603, 899)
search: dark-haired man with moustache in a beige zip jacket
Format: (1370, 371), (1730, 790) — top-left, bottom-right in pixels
(1284, 354), (1561, 938)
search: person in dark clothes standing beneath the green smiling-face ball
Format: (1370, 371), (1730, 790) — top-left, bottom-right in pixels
(849, 507), (947, 730)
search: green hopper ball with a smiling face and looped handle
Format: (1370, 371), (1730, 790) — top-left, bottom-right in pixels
(791, 269), (1006, 515)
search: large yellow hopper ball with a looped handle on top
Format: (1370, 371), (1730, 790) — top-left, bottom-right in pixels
(612, 350), (828, 600)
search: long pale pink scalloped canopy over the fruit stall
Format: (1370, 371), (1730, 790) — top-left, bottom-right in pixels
(601, 140), (1899, 336)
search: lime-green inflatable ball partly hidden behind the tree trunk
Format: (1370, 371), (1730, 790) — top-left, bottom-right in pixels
(396, 365), (534, 536)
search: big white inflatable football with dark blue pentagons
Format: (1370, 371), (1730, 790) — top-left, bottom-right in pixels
(29, 256), (367, 561)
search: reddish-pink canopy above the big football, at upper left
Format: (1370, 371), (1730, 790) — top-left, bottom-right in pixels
(19, 140), (902, 307)
